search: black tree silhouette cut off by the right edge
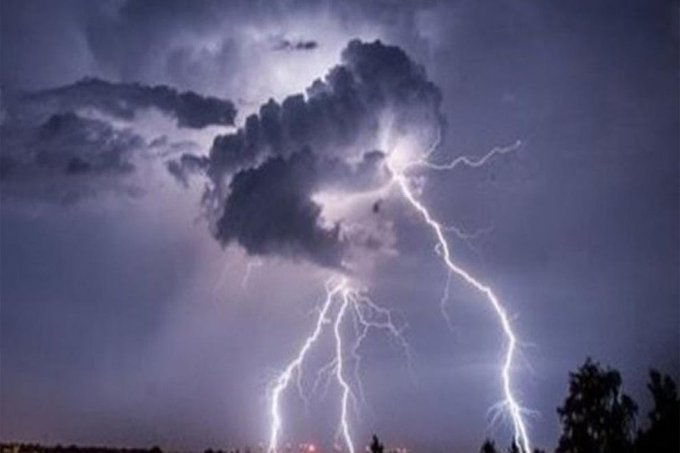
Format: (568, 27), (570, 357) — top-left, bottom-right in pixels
(635, 370), (680, 453)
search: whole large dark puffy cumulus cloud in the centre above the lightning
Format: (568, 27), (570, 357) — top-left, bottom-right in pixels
(169, 40), (443, 267)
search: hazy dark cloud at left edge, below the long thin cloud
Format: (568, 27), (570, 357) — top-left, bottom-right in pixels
(0, 112), (145, 203)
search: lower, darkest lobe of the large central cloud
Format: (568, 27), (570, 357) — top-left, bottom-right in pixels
(215, 149), (383, 267)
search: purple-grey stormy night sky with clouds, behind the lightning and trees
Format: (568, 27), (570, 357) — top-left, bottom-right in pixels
(0, 0), (680, 452)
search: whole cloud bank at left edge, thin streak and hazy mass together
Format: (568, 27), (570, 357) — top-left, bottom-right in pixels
(0, 78), (236, 202)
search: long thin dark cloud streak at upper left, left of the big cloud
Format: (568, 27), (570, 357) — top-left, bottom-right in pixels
(25, 78), (236, 128)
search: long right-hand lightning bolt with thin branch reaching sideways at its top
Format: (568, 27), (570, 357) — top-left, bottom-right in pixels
(386, 146), (531, 453)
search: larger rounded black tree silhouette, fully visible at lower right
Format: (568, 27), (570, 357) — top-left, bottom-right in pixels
(556, 358), (637, 453)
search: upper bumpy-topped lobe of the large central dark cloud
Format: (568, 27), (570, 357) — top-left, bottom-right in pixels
(190, 41), (443, 182)
